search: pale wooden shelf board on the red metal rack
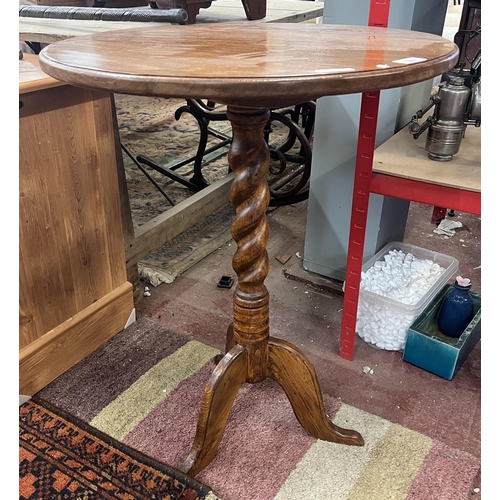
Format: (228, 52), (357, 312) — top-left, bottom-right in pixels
(373, 118), (481, 193)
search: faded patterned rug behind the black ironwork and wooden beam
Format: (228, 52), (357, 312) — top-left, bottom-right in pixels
(115, 94), (308, 286)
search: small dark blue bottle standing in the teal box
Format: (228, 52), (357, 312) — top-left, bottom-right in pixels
(437, 276), (473, 338)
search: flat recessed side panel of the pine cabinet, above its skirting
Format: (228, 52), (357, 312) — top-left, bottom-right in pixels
(19, 86), (126, 347)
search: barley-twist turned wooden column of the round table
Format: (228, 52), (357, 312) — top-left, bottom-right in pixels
(227, 106), (270, 382)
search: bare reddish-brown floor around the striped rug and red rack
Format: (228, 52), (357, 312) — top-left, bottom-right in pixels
(136, 201), (481, 464)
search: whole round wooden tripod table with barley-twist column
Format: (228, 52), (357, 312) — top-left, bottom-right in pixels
(40, 22), (458, 476)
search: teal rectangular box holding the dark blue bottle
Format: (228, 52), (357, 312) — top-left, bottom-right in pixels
(403, 285), (481, 380)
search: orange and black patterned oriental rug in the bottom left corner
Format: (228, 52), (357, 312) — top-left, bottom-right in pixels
(19, 399), (217, 500)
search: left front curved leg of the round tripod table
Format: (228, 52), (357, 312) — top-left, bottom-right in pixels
(180, 345), (247, 477)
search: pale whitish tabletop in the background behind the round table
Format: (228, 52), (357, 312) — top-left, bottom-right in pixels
(19, 0), (324, 43)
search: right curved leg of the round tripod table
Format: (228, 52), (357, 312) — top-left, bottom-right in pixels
(268, 337), (364, 446)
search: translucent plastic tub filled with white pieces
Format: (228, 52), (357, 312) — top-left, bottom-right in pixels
(356, 242), (458, 351)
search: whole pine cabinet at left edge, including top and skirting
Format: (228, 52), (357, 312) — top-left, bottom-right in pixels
(19, 55), (134, 395)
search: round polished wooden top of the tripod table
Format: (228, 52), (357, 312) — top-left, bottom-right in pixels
(40, 22), (458, 107)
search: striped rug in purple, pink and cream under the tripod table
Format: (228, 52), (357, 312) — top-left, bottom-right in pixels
(38, 318), (480, 500)
